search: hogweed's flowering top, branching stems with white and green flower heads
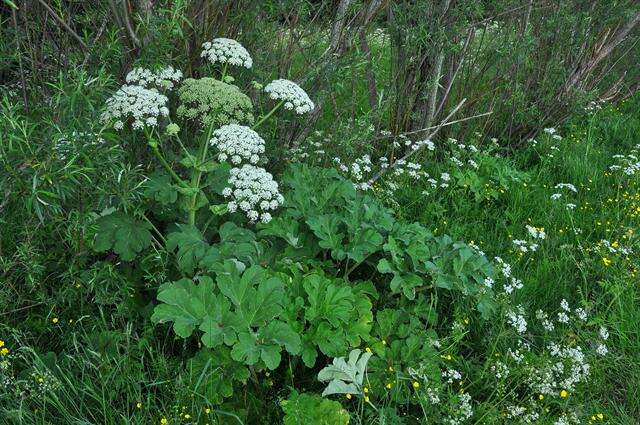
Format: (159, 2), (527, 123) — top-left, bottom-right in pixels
(102, 38), (314, 226)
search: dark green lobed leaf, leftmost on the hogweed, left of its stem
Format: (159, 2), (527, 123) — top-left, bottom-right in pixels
(93, 212), (151, 261)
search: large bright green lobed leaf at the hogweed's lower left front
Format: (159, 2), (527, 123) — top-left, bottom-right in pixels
(151, 260), (301, 369)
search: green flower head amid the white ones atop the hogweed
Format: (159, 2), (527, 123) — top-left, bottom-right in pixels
(177, 77), (253, 128)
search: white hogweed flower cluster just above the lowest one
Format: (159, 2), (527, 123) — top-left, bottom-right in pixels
(209, 124), (264, 165)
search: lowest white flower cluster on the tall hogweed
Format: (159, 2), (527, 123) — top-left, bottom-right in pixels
(222, 164), (284, 223)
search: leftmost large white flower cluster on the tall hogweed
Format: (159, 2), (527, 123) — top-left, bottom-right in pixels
(101, 86), (169, 130)
